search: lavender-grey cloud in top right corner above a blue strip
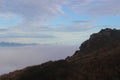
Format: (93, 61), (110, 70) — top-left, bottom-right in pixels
(68, 0), (120, 17)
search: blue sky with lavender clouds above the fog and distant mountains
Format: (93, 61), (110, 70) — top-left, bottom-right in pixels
(0, 0), (120, 45)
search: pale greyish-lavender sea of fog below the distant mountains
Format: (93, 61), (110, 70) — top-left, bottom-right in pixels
(0, 45), (79, 75)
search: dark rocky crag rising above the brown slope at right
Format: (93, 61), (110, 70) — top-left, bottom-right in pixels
(74, 28), (120, 55)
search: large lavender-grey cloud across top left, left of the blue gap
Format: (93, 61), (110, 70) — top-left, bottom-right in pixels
(0, 0), (64, 20)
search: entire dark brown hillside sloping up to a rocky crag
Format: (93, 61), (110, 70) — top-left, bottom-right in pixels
(0, 28), (120, 80)
